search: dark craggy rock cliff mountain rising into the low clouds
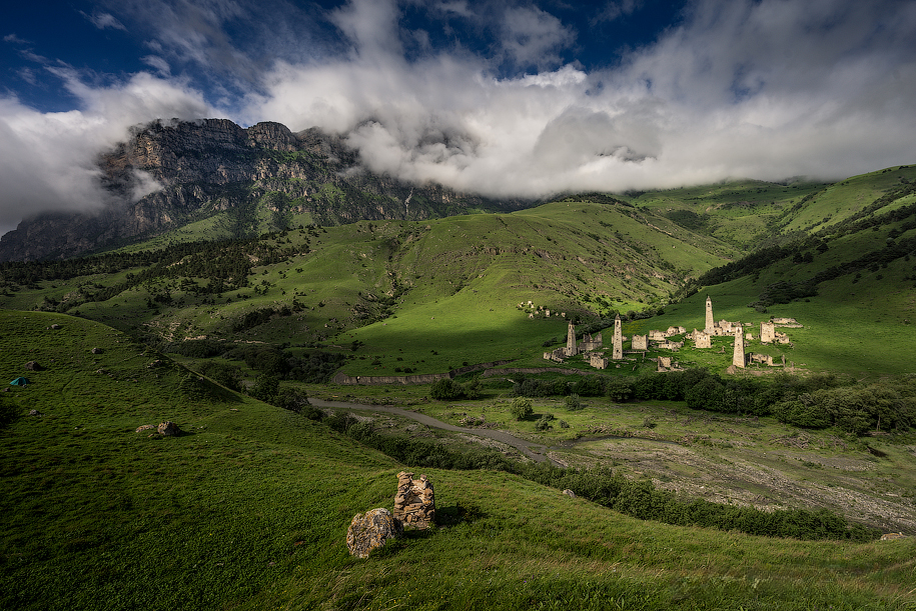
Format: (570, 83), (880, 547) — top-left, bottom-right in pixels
(0, 119), (527, 261)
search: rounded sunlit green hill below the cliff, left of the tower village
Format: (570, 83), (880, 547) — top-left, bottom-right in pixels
(3, 200), (734, 374)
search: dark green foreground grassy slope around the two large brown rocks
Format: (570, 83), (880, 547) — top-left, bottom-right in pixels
(0, 312), (916, 610)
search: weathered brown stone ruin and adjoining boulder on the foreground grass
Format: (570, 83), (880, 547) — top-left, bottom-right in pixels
(347, 471), (436, 558)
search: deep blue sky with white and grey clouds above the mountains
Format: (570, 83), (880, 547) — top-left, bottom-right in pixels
(0, 0), (916, 233)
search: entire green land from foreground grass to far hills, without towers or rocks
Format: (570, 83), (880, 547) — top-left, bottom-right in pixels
(0, 167), (916, 609)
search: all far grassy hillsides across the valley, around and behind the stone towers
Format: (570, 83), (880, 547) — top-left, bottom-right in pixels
(0, 168), (916, 382)
